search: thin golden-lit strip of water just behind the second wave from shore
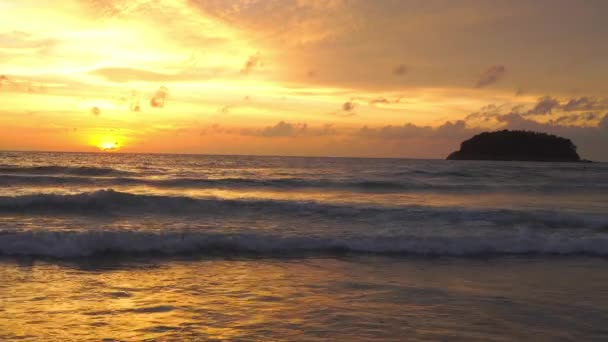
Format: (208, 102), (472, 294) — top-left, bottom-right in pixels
(0, 186), (605, 213)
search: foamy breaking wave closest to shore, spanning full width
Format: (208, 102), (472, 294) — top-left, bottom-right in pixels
(0, 230), (608, 258)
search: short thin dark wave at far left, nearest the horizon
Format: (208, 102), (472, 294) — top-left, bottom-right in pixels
(0, 165), (133, 176)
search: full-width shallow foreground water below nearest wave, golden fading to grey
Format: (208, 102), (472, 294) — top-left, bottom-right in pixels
(0, 257), (608, 341)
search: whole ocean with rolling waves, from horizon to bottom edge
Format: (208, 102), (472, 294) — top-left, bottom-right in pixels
(0, 152), (608, 341)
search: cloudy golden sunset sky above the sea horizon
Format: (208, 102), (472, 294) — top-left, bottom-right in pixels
(0, 0), (608, 161)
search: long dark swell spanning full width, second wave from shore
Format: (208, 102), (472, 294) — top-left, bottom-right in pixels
(0, 189), (608, 228)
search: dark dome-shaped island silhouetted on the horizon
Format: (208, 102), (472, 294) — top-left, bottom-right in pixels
(447, 130), (588, 162)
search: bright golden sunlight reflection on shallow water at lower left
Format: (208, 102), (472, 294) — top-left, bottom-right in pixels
(0, 262), (338, 340)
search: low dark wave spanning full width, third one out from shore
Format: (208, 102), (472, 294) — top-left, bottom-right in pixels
(0, 175), (608, 193)
